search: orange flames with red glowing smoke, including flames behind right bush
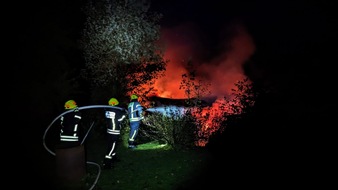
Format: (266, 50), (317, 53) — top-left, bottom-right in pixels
(133, 21), (255, 146)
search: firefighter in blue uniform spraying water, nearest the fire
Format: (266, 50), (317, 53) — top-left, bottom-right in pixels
(128, 94), (144, 149)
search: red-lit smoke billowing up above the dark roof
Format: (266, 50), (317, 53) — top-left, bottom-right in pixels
(155, 22), (255, 99)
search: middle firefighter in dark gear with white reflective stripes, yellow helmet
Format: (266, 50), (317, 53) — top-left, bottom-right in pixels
(103, 98), (127, 169)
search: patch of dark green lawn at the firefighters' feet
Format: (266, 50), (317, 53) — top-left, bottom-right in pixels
(81, 131), (208, 190)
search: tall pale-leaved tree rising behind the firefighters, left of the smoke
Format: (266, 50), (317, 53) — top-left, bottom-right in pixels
(80, 0), (166, 100)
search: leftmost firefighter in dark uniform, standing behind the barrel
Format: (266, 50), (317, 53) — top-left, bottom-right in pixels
(60, 100), (81, 148)
